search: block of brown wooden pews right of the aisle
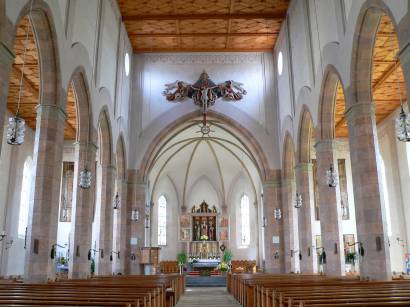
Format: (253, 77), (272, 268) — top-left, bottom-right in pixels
(228, 274), (410, 307)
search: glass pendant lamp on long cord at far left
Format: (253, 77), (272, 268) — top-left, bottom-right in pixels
(6, 1), (33, 145)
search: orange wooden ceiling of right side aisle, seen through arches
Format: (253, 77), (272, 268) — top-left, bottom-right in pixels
(335, 15), (407, 137)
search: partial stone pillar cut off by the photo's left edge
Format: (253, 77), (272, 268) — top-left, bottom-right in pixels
(0, 41), (15, 152)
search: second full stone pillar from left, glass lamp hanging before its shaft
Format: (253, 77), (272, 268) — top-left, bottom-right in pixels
(68, 143), (97, 278)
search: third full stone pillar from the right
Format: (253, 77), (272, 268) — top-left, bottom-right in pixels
(295, 163), (317, 273)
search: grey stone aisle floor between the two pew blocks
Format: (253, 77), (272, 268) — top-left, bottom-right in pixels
(176, 287), (240, 307)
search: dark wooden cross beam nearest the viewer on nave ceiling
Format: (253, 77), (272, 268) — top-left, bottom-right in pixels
(122, 11), (286, 21)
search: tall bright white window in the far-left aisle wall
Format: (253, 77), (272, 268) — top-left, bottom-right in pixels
(18, 157), (32, 239)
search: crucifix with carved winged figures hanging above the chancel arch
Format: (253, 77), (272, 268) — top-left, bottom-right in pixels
(162, 71), (246, 136)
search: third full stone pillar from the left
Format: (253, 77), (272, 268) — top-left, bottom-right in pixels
(97, 165), (115, 275)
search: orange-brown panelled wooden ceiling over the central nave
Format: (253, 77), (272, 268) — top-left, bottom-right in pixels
(118, 0), (290, 52)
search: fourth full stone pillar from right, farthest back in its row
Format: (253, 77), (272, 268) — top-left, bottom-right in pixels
(281, 179), (299, 273)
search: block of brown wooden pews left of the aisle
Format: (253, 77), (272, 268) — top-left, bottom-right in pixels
(0, 274), (185, 307)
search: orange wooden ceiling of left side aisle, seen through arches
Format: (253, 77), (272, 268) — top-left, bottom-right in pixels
(7, 16), (77, 140)
